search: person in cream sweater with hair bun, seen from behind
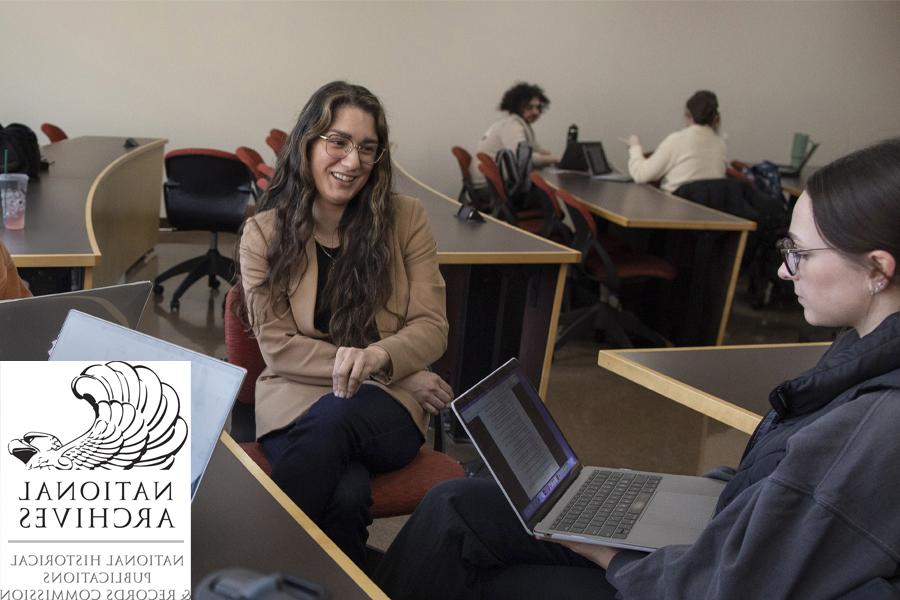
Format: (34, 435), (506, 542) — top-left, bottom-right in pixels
(622, 90), (726, 192)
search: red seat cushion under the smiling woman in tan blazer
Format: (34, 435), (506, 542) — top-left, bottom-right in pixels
(240, 442), (465, 519)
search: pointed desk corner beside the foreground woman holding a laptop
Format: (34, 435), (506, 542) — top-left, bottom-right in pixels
(597, 342), (831, 434)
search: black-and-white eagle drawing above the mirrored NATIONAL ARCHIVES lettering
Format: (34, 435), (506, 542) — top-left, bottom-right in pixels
(8, 362), (188, 470)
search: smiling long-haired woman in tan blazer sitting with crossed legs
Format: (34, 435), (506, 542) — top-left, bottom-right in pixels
(240, 82), (452, 563)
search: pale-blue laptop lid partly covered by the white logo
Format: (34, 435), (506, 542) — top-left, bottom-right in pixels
(50, 310), (247, 499)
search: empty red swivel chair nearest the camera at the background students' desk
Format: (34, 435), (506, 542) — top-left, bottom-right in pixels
(555, 188), (675, 348)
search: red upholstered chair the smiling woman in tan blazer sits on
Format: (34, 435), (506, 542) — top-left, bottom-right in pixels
(225, 286), (465, 519)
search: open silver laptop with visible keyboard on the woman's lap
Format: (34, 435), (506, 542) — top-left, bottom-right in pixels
(451, 358), (724, 551)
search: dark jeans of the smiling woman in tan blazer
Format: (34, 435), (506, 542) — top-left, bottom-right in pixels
(260, 385), (424, 565)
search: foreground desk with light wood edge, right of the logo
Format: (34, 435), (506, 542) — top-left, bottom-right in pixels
(191, 433), (387, 600)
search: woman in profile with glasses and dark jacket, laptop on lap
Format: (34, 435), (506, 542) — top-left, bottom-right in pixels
(376, 139), (900, 600)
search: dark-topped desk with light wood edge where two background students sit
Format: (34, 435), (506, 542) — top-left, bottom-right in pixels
(542, 169), (756, 345)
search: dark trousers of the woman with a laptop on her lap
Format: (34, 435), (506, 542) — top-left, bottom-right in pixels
(374, 479), (616, 600)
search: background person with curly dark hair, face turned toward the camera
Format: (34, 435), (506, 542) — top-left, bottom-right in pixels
(470, 83), (559, 189)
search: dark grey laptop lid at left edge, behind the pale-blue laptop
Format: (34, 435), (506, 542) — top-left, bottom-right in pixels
(0, 281), (153, 360)
